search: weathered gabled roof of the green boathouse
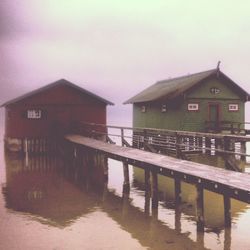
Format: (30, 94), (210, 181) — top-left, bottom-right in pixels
(124, 68), (250, 104)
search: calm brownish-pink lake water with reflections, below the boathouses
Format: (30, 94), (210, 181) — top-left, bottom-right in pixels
(0, 124), (250, 250)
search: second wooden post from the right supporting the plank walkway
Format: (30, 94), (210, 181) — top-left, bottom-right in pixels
(196, 184), (204, 232)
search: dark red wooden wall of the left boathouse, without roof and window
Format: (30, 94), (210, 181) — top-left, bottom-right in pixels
(5, 85), (106, 138)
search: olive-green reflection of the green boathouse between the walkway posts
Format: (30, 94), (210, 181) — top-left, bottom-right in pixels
(134, 167), (246, 230)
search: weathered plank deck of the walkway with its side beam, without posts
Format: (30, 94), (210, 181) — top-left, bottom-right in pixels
(65, 135), (250, 203)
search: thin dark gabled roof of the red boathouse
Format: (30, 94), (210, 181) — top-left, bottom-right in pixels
(1, 79), (114, 107)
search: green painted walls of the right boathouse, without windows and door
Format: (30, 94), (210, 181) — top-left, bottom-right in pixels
(133, 79), (245, 132)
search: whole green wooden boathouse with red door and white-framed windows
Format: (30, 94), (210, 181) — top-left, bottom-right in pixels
(124, 67), (250, 132)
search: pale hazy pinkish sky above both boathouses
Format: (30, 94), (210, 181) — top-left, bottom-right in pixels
(0, 0), (250, 121)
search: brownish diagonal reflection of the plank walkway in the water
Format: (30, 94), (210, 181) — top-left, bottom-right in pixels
(102, 187), (207, 250)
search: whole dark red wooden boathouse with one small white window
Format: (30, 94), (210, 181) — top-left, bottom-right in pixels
(2, 79), (113, 151)
